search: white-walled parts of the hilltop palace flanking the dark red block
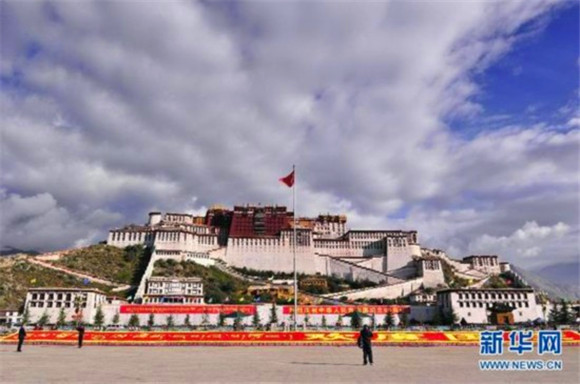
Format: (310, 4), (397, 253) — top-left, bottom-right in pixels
(107, 212), (421, 274)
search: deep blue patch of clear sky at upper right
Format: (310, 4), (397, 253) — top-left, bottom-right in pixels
(450, 2), (580, 135)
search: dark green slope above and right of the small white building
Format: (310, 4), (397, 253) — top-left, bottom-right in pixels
(152, 259), (253, 304)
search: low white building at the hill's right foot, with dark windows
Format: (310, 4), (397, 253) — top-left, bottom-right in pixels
(437, 288), (538, 324)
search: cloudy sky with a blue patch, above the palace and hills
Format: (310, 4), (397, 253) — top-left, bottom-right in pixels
(0, 0), (580, 267)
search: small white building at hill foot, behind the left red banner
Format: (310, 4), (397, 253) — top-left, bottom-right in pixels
(143, 277), (203, 304)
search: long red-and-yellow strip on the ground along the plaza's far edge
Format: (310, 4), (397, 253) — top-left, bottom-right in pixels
(0, 331), (580, 346)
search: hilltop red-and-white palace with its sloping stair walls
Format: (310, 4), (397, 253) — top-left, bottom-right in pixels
(107, 205), (509, 299)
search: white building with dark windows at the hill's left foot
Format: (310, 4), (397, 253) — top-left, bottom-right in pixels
(25, 288), (107, 324)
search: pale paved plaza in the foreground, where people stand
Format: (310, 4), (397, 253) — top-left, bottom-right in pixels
(0, 345), (580, 384)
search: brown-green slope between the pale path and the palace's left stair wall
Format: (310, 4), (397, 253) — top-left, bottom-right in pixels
(53, 244), (151, 285)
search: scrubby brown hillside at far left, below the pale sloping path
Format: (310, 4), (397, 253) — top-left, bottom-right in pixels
(0, 256), (110, 309)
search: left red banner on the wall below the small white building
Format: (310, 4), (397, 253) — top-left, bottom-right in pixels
(119, 304), (256, 315)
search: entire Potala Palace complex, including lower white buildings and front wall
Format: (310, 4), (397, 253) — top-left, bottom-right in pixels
(11, 205), (568, 325)
